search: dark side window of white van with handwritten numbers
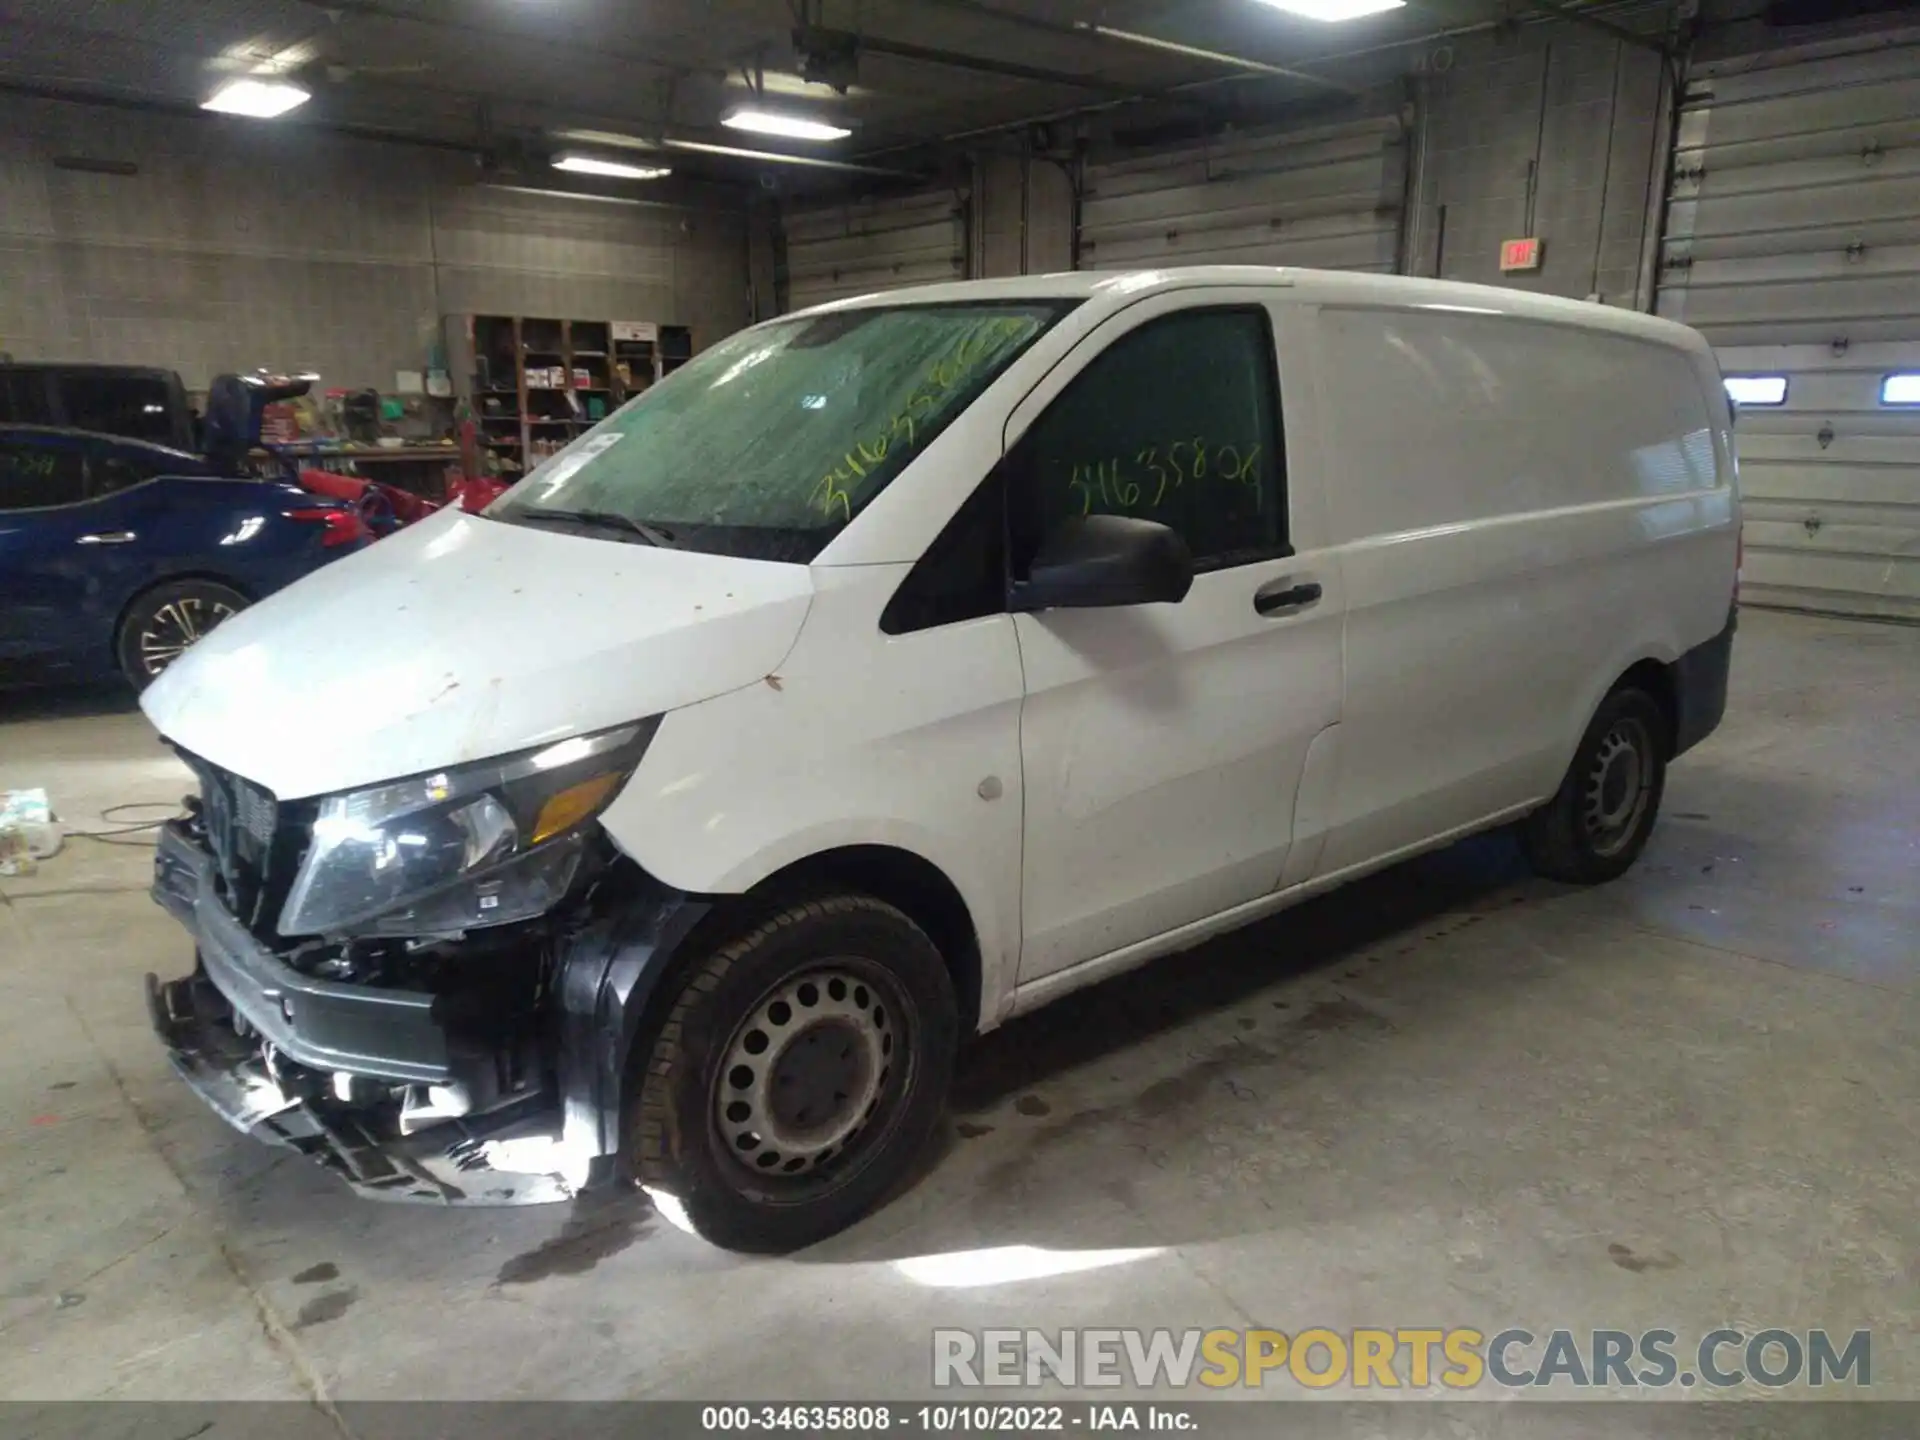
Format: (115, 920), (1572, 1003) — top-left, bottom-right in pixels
(1010, 307), (1286, 576)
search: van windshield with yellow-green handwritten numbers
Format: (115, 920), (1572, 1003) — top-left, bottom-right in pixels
(486, 301), (1075, 563)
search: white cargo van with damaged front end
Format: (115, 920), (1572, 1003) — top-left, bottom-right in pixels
(142, 269), (1740, 1248)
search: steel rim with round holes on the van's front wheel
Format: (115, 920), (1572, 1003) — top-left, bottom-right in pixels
(712, 960), (906, 1181)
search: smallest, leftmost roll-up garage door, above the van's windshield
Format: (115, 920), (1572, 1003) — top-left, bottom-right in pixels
(783, 190), (966, 309)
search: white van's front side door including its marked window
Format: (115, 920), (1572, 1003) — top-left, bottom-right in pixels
(1006, 288), (1342, 983)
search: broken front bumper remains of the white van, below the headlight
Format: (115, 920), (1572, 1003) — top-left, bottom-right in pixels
(146, 822), (584, 1206)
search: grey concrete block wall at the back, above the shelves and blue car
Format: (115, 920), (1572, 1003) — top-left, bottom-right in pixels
(0, 96), (749, 388)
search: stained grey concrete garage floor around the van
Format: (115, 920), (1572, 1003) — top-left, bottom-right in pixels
(0, 612), (1920, 1400)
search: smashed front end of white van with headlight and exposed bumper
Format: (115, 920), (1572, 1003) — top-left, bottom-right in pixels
(148, 737), (672, 1204)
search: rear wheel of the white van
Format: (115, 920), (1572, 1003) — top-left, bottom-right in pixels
(1521, 685), (1672, 885)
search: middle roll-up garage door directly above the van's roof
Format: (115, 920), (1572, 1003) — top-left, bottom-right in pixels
(1081, 117), (1405, 271)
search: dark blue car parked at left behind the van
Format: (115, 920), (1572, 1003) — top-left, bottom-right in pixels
(0, 426), (372, 689)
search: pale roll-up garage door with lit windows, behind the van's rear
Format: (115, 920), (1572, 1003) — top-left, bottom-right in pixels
(1659, 44), (1920, 618)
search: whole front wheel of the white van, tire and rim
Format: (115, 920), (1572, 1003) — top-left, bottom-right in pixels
(628, 895), (958, 1254)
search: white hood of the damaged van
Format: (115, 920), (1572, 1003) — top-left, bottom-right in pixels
(140, 509), (812, 801)
